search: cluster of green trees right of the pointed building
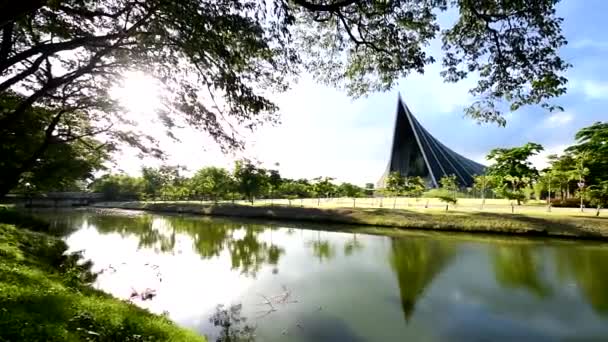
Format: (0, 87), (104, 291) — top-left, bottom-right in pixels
(474, 122), (608, 215)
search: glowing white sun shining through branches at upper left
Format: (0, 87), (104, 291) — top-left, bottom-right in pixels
(112, 71), (160, 118)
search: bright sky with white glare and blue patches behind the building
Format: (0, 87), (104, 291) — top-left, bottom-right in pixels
(111, 0), (608, 185)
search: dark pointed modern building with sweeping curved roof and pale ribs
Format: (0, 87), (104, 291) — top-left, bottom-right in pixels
(377, 97), (485, 188)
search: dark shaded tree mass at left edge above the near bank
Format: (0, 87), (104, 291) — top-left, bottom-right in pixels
(0, 94), (112, 195)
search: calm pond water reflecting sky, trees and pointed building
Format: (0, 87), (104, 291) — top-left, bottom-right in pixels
(36, 211), (608, 341)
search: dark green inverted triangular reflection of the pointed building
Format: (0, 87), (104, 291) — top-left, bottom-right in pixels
(389, 238), (455, 321)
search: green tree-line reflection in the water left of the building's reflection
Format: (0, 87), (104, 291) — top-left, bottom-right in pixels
(89, 214), (285, 277)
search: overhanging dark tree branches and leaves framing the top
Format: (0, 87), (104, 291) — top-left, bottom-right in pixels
(0, 0), (569, 195)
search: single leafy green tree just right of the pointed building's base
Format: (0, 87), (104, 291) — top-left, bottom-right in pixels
(486, 142), (543, 205)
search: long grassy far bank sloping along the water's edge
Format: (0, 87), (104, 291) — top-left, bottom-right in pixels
(97, 202), (608, 239)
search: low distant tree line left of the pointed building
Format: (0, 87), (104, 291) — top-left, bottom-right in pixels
(90, 160), (373, 204)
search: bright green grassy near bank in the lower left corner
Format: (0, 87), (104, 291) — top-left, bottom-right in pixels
(0, 209), (204, 341)
